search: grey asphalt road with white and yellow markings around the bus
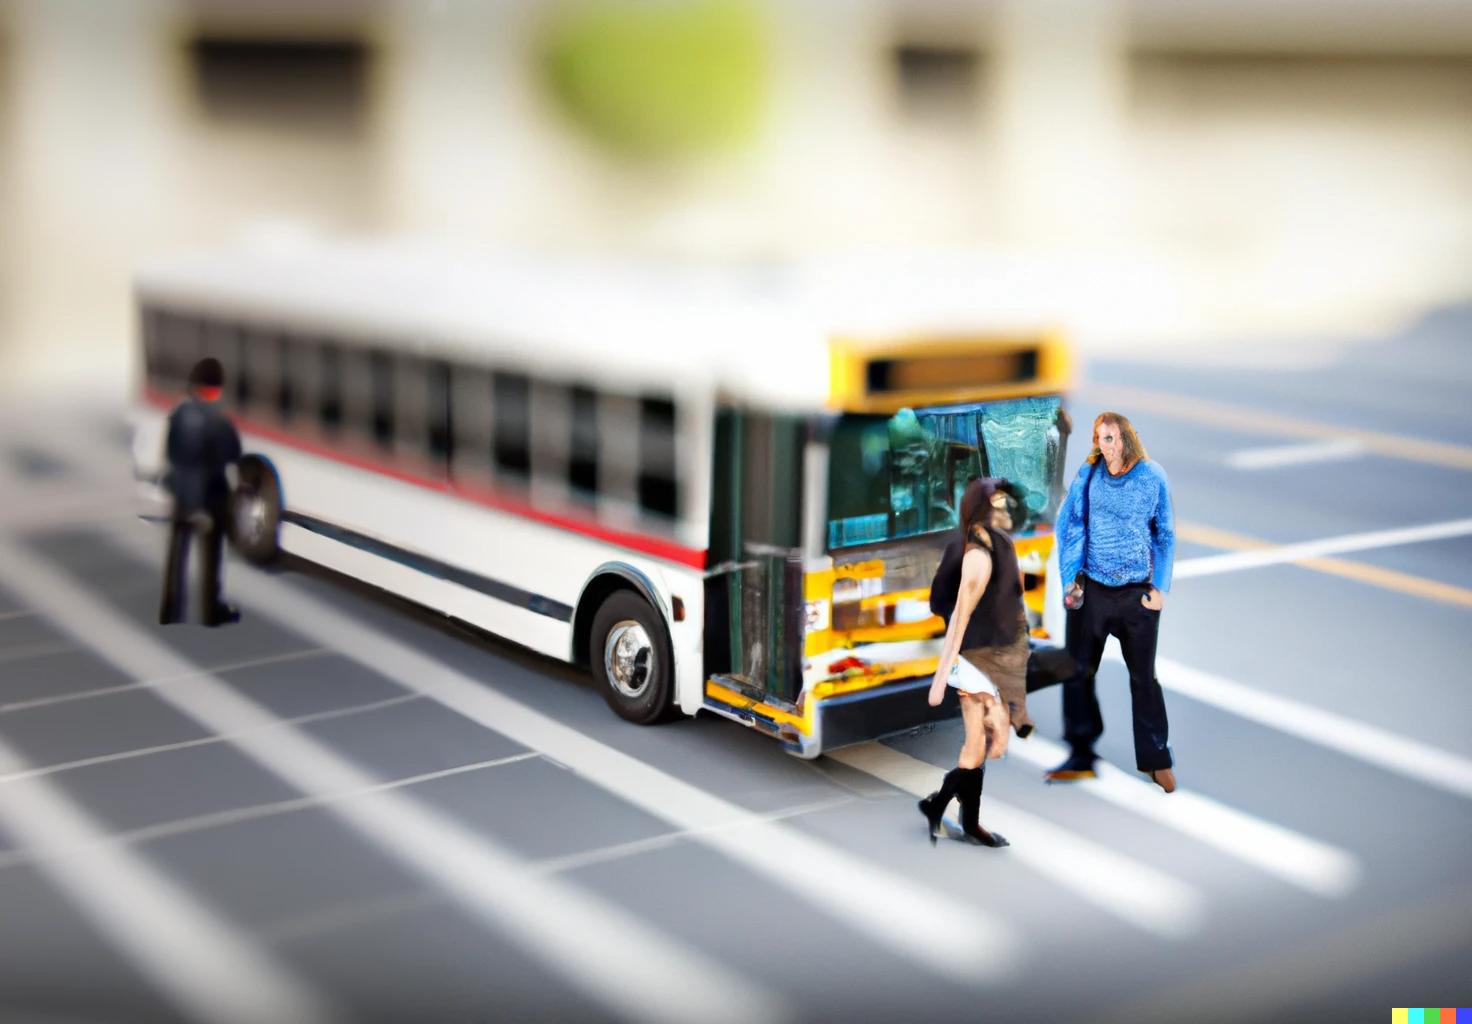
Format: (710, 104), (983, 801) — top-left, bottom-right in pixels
(0, 310), (1472, 1024)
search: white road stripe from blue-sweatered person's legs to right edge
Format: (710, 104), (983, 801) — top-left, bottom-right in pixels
(1104, 644), (1472, 799)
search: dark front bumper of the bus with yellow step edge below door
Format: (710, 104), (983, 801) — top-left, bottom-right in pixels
(704, 675), (961, 759)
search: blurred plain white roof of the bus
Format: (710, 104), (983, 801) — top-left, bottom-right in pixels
(134, 243), (1071, 410)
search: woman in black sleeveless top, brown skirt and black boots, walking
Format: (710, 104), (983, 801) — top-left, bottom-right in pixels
(920, 478), (1032, 846)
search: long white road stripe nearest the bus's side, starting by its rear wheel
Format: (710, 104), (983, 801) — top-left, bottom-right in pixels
(113, 524), (1022, 984)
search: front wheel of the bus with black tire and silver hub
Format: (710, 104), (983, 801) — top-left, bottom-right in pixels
(587, 590), (674, 725)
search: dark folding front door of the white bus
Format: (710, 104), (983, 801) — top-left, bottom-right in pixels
(705, 409), (808, 703)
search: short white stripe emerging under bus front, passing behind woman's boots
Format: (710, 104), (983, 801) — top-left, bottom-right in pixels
(827, 743), (1204, 939)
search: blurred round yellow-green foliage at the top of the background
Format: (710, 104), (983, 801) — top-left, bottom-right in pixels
(540, 0), (767, 157)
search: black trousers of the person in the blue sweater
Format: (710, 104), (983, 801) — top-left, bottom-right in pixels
(1063, 577), (1172, 771)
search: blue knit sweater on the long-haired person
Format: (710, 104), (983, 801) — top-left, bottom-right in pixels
(1055, 458), (1176, 593)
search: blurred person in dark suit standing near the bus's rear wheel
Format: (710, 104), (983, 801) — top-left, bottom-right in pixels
(159, 359), (240, 625)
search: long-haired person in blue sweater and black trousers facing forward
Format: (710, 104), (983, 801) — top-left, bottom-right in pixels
(1047, 412), (1176, 793)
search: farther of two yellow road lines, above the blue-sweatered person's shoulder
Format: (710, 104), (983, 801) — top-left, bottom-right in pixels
(1080, 384), (1472, 469)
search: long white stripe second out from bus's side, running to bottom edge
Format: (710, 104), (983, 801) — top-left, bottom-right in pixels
(0, 543), (790, 1024)
